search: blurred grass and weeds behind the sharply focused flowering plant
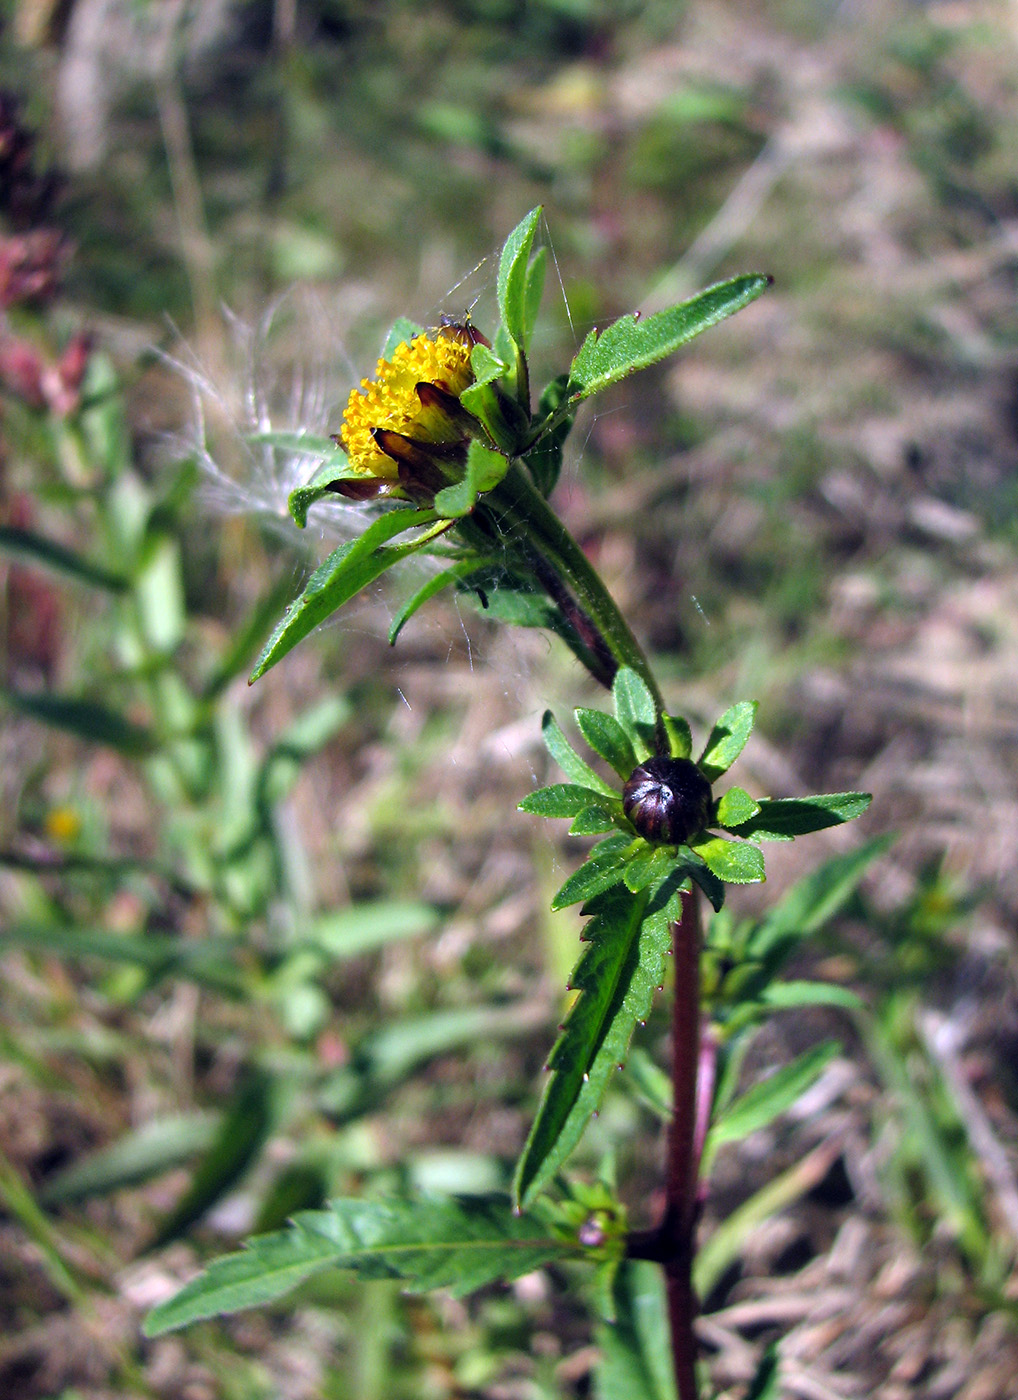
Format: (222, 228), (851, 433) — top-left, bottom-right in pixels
(0, 0), (1018, 1400)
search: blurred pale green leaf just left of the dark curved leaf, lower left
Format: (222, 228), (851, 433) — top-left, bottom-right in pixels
(39, 1112), (217, 1205)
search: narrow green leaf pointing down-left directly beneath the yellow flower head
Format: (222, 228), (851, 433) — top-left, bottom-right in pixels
(251, 510), (437, 682)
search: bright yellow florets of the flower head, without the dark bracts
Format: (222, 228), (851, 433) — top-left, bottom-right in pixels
(339, 326), (475, 482)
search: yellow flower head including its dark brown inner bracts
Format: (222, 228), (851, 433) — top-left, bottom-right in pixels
(337, 325), (487, 498)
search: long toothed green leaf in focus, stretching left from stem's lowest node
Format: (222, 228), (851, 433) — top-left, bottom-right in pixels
(144, 1196), (577, 1337)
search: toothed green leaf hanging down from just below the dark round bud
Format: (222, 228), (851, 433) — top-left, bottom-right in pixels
(514, 879), (678, 1205)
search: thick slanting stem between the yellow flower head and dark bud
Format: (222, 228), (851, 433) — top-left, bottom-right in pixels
(484, 462), (665, 715)
